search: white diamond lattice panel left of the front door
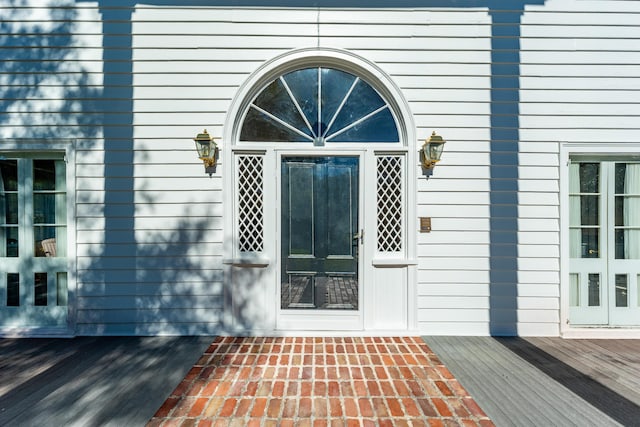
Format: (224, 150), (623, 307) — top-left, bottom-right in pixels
(238, 155), (264, 252)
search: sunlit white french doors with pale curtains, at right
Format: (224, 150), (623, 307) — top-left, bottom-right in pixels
(569, 160), (640, 326)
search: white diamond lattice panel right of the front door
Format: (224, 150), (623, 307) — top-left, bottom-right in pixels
(376, 156), (402, 252)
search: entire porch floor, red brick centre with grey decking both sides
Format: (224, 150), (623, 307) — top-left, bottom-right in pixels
(0, 337), (640, 426)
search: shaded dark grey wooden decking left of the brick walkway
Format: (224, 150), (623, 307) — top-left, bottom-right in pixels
(0, 337), (212, 426)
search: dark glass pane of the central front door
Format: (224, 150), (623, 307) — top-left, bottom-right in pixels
(281, 157), (359, 310)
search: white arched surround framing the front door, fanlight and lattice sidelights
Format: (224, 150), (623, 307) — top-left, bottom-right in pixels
(222, 48), (416, 333)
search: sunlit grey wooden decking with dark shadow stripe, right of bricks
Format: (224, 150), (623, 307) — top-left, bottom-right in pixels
(425, 337), (640, 426)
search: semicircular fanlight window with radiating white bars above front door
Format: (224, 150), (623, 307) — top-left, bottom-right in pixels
(240, 67), (400, 145)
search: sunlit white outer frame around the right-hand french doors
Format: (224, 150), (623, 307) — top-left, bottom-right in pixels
(560, 142), (640, 339)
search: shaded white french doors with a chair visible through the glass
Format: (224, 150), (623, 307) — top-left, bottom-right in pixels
(0, 156), (68, 329)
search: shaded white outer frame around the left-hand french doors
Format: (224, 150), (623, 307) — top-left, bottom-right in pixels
(0, 138), (77, 337)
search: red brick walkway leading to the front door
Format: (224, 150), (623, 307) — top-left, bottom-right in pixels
(148, 337), (493, 427)
